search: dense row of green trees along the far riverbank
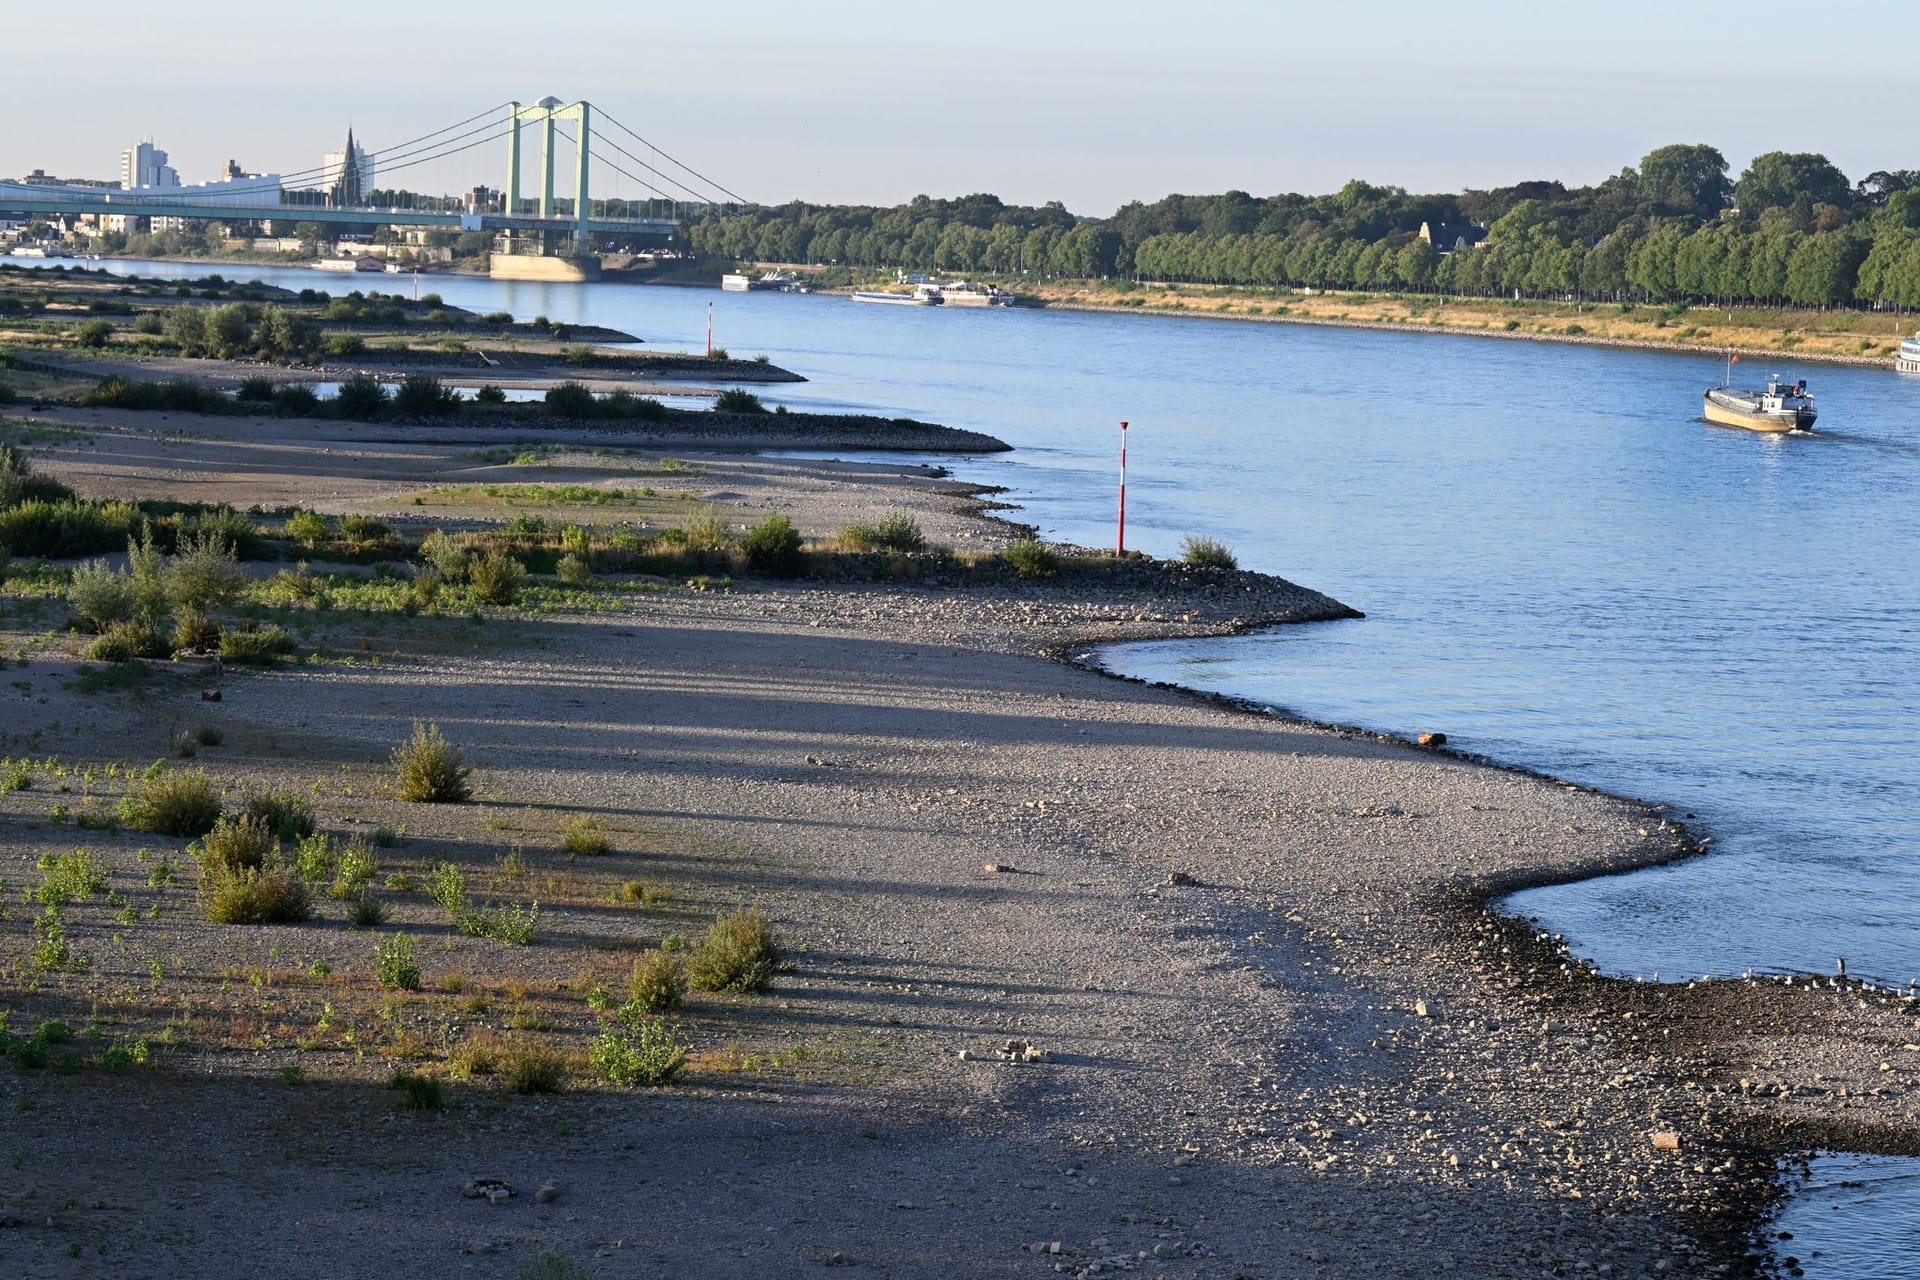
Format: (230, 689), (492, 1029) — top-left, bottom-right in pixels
(682, 144), (1920, 307)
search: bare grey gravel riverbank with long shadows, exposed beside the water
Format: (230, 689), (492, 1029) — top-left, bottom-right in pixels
(0, 404), (1920, 1278)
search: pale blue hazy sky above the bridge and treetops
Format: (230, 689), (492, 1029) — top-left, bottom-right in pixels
(0, 0), (1920, 215)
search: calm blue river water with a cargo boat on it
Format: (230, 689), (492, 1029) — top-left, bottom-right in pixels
(26, 263), (1920, 1276)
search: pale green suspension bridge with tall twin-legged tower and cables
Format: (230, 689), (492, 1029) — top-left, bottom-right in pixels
(0, 98), (745, 278)
